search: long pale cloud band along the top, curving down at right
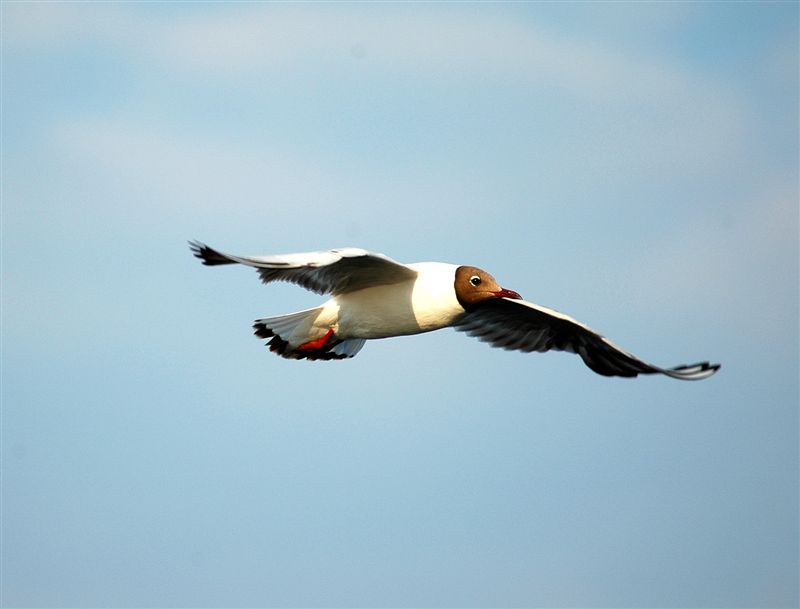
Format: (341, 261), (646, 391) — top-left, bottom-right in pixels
(5, 3), (748, 180)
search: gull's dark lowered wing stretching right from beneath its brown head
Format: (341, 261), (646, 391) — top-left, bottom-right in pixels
(456, 298), (720, 380)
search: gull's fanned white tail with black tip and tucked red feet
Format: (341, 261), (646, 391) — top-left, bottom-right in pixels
(253, 307), (365, 360)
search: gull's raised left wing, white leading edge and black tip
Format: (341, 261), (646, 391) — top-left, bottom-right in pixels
(189, 241), (417, 295)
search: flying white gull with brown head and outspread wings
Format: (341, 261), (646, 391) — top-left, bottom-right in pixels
(189, 241), (720, 380)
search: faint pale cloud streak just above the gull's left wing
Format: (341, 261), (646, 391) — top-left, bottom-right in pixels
(52, 119), (478, 257)
